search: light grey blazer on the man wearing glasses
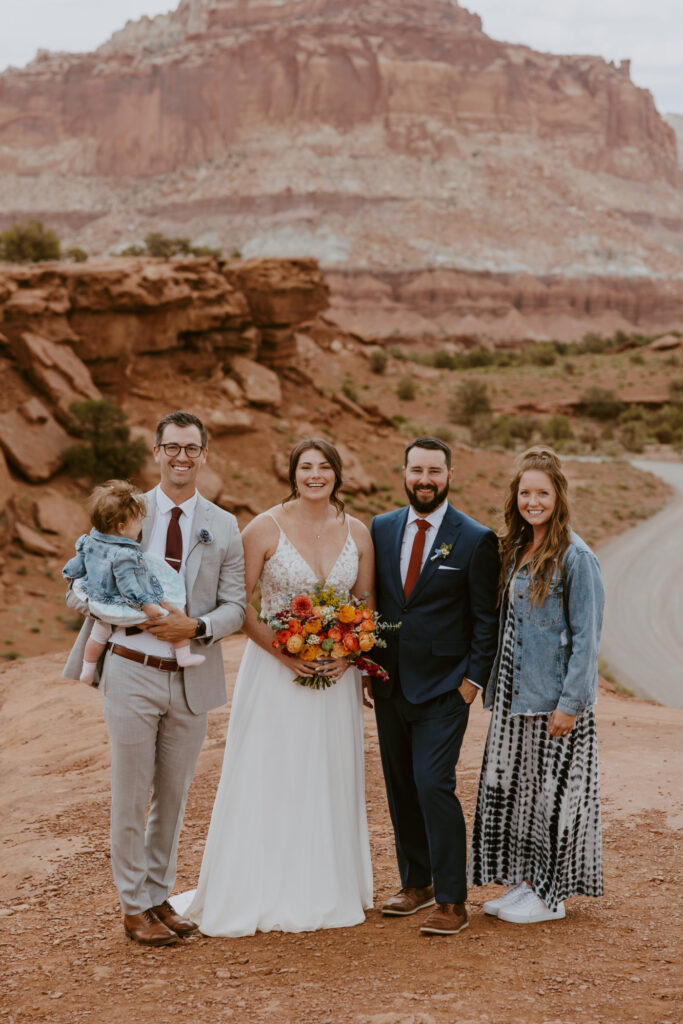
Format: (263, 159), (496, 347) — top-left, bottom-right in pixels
(63, 489), (247, 715)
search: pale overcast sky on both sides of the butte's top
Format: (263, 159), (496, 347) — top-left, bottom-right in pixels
(0, 0), (683, 114)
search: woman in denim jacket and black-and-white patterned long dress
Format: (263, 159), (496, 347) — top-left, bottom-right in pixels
(469, 445), (604, 924)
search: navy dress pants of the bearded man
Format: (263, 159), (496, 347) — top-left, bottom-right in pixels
(375, 681), (470, 903)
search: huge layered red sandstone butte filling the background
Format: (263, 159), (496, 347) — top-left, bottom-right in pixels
(0, 0), (683, 339)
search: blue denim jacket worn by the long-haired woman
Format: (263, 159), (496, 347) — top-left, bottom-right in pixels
(484, 531), (605, 715)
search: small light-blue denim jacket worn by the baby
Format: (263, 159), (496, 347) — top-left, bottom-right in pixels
(61, 527), (164, 608)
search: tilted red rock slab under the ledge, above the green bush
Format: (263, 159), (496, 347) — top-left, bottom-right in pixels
(10, 331), (101, 423)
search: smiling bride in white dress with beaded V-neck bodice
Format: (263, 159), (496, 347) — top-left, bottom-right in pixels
(172, 438), (374, 936)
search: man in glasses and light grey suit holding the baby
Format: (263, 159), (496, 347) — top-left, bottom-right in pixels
(65, 412), (247, 946)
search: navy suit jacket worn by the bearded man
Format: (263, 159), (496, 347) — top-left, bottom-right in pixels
(371, 504), (499, 703)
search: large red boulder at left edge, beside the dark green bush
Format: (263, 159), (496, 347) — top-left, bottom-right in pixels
(0, 398), (75, 483)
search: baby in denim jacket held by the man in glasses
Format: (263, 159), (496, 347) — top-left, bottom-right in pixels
(61, 480), (206, 684)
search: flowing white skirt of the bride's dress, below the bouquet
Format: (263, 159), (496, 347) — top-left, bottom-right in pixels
(171, 640), (373, 936)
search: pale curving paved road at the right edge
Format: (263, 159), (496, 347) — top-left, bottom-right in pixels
(599, 459), (683, 708)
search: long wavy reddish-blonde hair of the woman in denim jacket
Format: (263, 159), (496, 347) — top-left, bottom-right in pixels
(499, 444), (570, 605)
